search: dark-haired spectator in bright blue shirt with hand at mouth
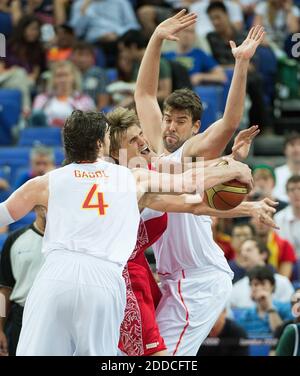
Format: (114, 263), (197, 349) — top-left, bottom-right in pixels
(237, 266), (291, 336)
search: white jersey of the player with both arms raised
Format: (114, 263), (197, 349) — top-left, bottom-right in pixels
(151, 145), (233, 276)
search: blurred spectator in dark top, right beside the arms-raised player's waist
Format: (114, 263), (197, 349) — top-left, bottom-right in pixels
(229, 222), (255, 283)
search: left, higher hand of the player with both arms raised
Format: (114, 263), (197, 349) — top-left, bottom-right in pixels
(154, 9), (197, 41)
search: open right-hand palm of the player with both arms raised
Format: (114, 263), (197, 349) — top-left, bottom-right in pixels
(229, 25), (265, 60)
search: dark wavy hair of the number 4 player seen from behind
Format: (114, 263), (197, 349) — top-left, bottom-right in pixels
(63, 110), (108, 164)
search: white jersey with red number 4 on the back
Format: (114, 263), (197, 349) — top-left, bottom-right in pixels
(43, 161), (140, 266)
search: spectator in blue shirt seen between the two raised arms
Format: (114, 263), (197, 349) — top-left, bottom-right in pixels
(163, 25), (226, 86)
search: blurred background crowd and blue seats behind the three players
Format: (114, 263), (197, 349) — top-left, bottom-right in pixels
(0, 0), (300, 356)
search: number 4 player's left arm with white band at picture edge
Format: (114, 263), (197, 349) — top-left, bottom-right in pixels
(0, 174), (48, 227)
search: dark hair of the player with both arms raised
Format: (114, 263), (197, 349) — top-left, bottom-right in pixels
(163, 89), (203, 122)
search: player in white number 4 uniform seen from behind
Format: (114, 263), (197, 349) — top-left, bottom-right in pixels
(0, 111), (213, 355)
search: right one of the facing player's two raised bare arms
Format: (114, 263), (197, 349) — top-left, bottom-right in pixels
(183, 26), (264, 159)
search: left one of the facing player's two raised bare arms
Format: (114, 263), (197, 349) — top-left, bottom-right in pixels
(134, 10), (197, 154)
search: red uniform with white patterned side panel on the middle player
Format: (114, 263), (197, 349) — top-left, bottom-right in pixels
(119, 213), (168, 356)
